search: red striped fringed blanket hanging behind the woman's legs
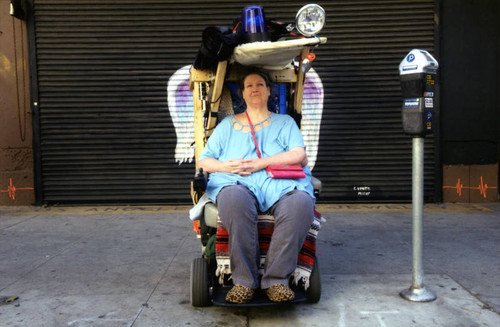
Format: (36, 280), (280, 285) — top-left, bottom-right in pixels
(215, 210), (323, 289)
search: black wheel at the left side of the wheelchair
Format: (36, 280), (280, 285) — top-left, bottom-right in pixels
(191, 258), (211, 307)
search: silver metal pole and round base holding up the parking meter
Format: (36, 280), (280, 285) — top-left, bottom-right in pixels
(400, 137), (436, 302)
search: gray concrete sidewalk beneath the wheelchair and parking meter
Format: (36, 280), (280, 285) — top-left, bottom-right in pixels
(0, 203), (500, 327)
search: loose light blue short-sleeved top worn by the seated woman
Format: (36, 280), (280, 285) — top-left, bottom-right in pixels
(199, 113), (314, 212)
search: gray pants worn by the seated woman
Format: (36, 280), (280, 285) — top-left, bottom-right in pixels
(217, 185), (314, 289)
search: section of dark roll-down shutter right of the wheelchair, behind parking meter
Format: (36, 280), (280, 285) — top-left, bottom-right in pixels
(314, 1), (438, 202)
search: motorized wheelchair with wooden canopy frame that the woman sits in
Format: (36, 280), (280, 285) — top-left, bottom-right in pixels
(189, 3), (326, 307)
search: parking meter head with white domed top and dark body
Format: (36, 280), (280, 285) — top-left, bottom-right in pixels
(399, 49), (439, 137)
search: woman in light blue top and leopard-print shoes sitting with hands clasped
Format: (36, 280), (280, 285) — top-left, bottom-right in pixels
(198, 70), (315, 303)
